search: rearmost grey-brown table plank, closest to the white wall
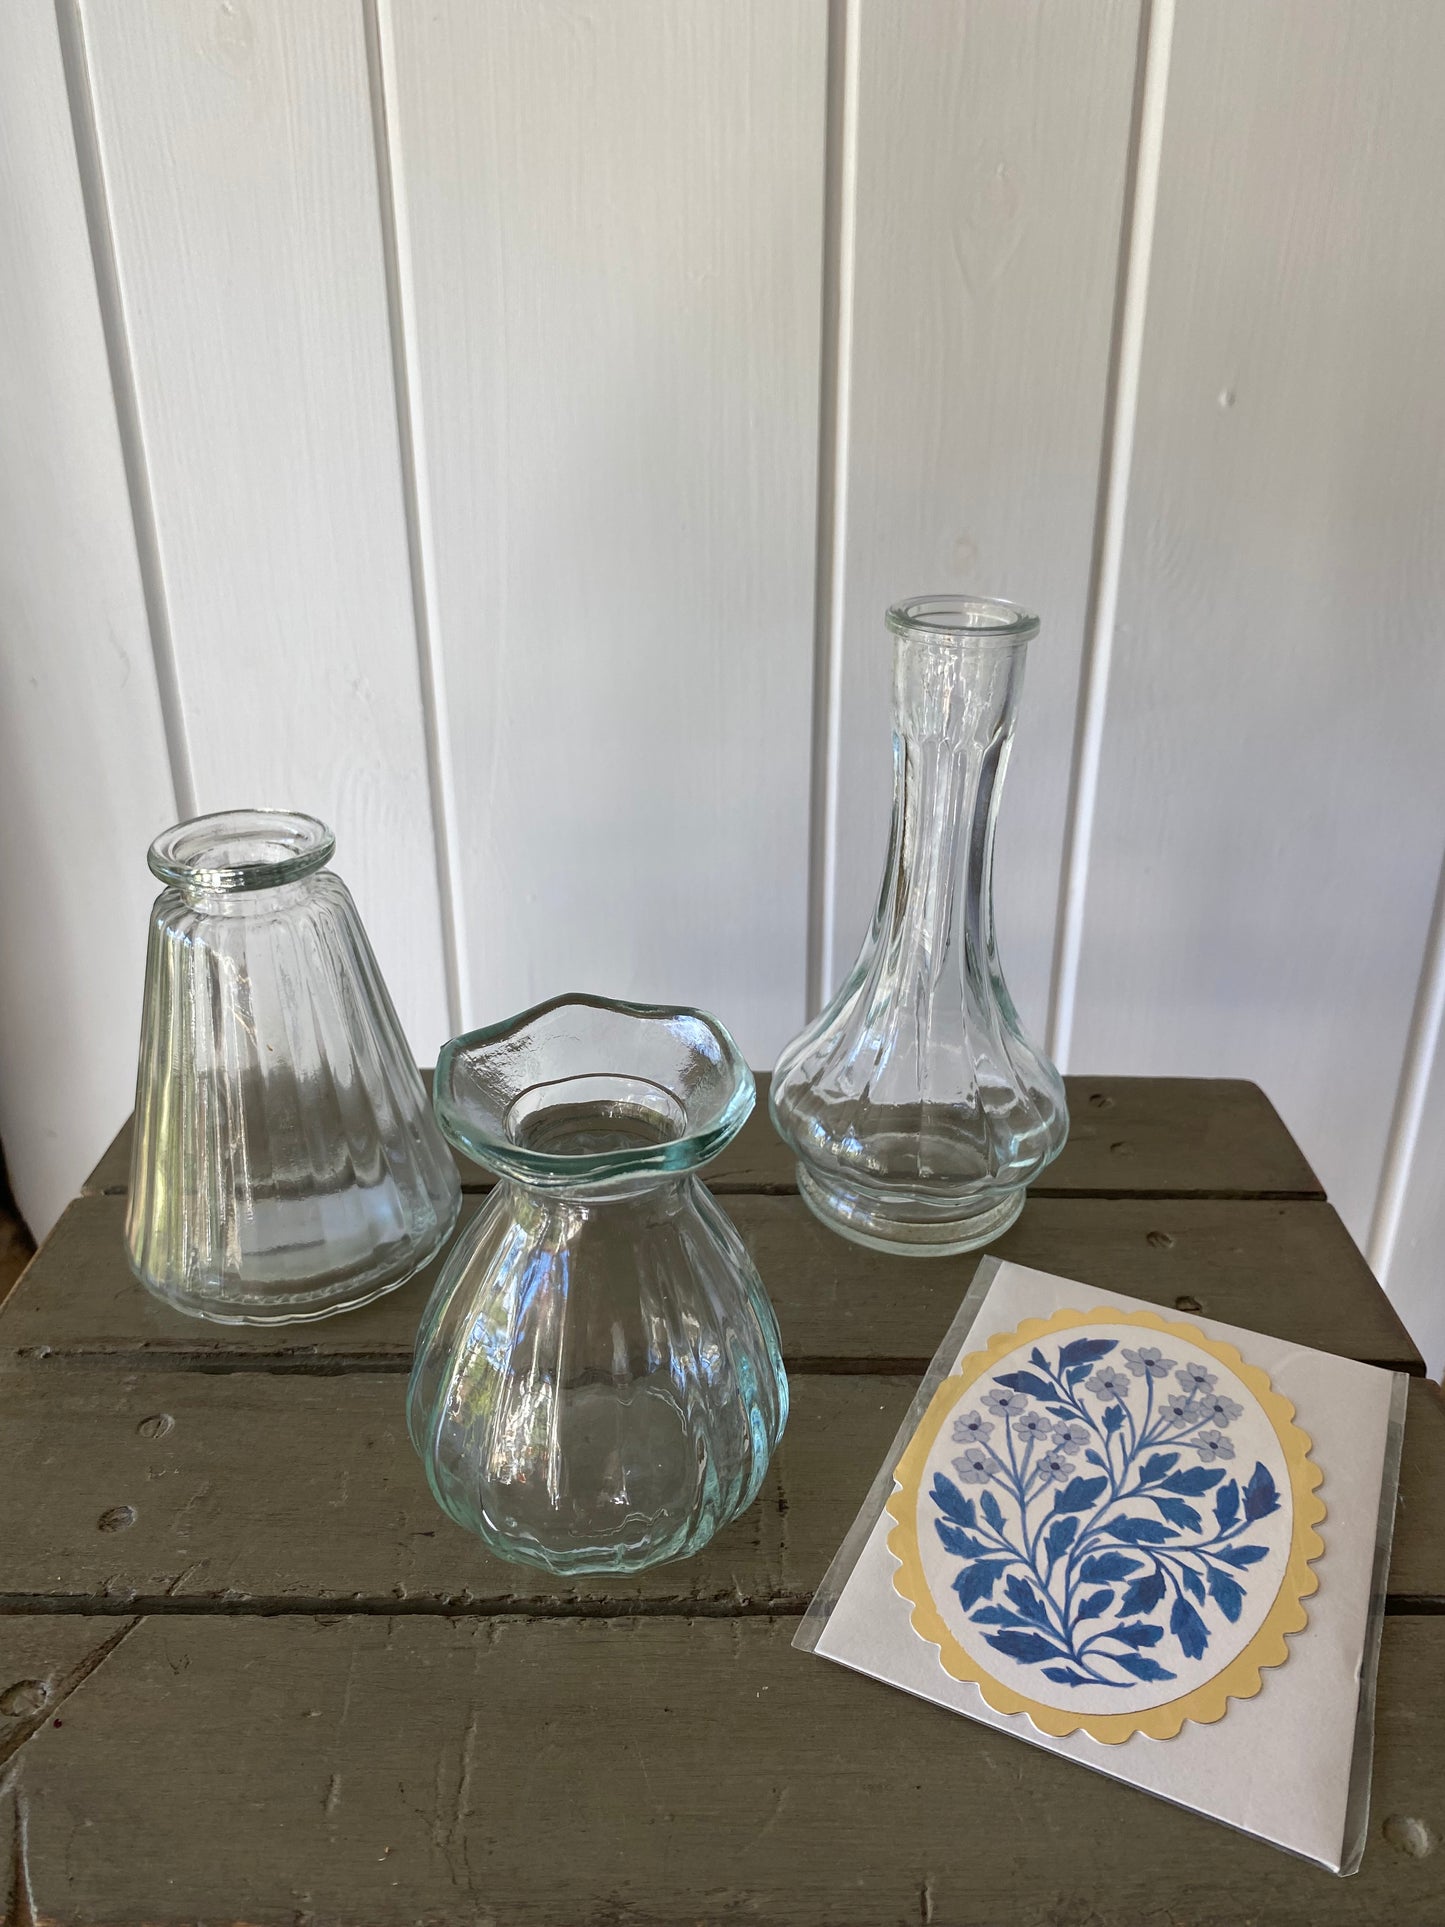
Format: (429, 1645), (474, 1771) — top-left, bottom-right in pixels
(81, 1071), (1324, 1199)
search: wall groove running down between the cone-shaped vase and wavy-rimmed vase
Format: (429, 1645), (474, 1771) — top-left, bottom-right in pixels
(362, 0), (470, 1037)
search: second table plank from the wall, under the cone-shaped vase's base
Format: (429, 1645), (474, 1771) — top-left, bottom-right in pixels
(0, 1197), (1424, 1374)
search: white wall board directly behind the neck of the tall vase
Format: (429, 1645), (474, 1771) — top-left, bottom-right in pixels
(823, 0), (1139, 1035)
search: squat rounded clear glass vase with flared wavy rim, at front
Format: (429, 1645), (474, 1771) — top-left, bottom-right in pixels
(407, 996), (788, 1572)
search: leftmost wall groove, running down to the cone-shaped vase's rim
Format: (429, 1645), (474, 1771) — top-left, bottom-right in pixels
(56, 0), (197, 831)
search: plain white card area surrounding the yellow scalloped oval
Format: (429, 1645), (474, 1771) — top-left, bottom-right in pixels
(800, 1262), (1397, 1871)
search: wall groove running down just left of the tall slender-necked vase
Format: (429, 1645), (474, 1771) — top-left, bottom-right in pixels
(807, 0), (861, 1017)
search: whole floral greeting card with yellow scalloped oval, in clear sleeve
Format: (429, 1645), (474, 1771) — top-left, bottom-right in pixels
(798, 1258), (1405, 1871)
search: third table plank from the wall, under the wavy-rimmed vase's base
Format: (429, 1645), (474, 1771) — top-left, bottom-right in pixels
(0, 1364), (1445, 1613)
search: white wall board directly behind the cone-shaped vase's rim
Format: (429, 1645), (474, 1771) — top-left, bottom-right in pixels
(81, 0), (447, 1054)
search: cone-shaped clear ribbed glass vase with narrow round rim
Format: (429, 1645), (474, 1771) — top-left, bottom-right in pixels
(125, 809), (460, 1324)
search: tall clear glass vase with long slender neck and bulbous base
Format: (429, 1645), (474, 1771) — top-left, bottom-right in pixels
(771, 595), (1069, 1254)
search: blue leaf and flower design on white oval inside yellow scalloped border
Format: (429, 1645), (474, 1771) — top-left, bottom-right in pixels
(931, 1337), (1279, 1690)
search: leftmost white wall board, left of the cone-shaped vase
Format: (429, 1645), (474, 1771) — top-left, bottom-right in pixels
(0, 0), (173, 1233)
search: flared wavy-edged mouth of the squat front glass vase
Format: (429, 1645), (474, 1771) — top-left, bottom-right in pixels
(435, 992), (753, 1187)
